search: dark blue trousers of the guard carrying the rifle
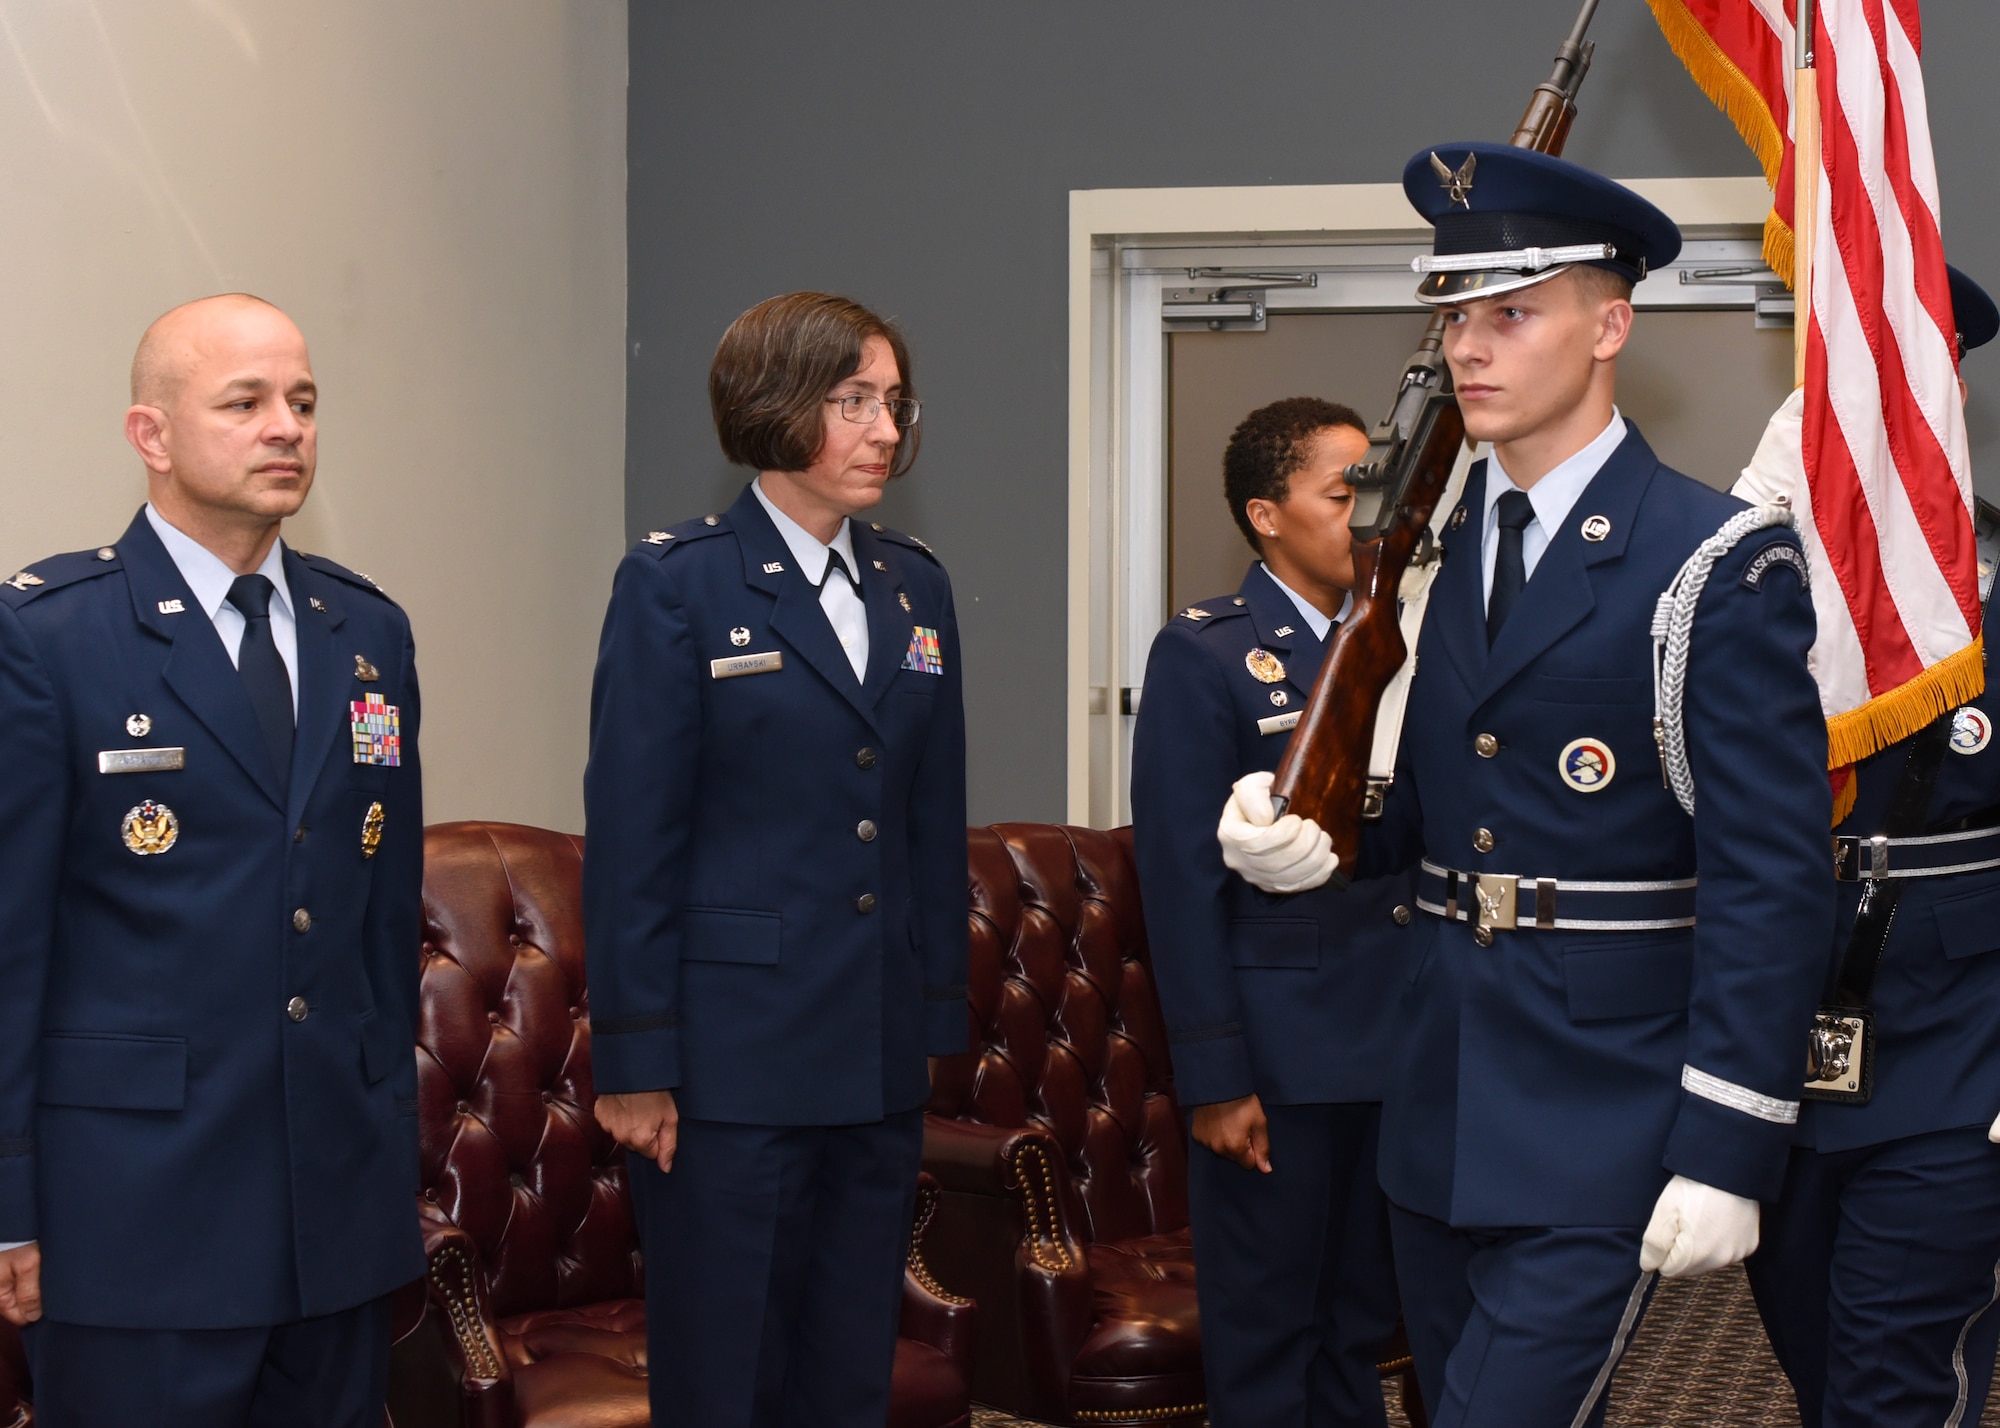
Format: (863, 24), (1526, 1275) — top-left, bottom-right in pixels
(1390, 1204), (1650, 1428)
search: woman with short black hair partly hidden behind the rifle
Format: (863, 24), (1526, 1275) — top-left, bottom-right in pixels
(1132, 398), (1414, 1428)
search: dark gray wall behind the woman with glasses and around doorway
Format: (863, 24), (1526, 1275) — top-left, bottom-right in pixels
(626, 0), (2000, 822)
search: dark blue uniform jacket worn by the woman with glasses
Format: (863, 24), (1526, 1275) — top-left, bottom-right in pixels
(584, 488), (968, 1126)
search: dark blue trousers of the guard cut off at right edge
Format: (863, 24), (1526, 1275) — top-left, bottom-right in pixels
(1748, 1126), (2000, 1428)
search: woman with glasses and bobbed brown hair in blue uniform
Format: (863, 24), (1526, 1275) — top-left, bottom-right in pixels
(584, 292), (966, 1428)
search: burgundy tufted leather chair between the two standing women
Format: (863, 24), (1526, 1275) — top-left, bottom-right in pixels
(924, 824), (1424, 1426)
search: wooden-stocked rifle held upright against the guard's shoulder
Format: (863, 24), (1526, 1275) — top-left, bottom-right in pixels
(1272, 0), (1598, 886)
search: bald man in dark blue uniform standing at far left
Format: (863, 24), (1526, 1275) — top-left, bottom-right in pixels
(0, 294), (424, 1428)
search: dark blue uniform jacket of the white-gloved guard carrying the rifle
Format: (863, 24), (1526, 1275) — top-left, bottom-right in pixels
(1364, 428), (1834, 1226)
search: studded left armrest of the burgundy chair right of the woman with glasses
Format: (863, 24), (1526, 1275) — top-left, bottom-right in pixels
(924, 1116), (1096, 1422)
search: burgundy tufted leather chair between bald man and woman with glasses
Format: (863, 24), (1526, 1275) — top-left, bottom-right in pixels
(396, 822), (974, 1428)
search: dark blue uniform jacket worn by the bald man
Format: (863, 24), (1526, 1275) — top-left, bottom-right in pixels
(0, 512), (424, 1328)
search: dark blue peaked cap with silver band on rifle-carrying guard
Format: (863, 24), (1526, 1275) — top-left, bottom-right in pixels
(1402, 144), (1680, 304)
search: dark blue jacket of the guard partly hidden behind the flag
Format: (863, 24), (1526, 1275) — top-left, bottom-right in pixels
(1798, 572), (2000, 1150)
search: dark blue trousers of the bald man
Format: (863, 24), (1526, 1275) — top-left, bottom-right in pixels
(22, 1296), (390, 1428)
